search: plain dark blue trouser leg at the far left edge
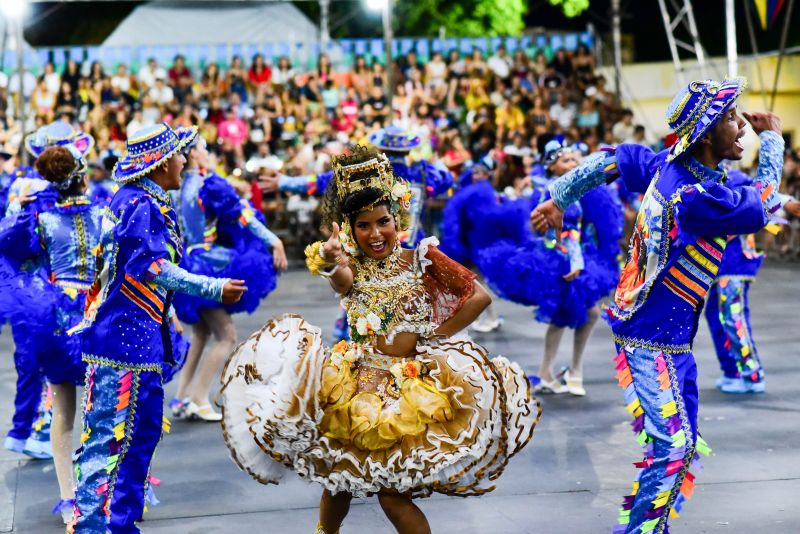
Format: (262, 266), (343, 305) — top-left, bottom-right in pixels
(8, 323), (51, 441)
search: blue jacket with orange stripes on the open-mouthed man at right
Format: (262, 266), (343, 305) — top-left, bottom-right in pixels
(551, 131), (784, 352)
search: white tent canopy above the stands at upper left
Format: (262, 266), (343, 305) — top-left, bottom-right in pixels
(103, 1), (319, 46)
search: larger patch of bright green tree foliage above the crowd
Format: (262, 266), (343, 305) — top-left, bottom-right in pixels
(395, 0), (528, 37)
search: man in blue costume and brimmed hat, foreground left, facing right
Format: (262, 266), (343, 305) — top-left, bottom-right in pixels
(71, 124), (246, 534)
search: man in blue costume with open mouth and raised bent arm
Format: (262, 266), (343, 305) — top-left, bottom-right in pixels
(531, 78), (784, 534)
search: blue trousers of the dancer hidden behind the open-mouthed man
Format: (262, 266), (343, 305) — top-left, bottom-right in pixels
(705, 277), (764, 382)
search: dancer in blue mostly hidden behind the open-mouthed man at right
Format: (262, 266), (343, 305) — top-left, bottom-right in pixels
(705, 169), (800, 394)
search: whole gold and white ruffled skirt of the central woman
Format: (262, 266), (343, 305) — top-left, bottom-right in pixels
(220, 315), (541, 496)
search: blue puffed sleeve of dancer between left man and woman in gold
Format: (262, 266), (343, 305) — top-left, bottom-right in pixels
(199, 175), (278, 246)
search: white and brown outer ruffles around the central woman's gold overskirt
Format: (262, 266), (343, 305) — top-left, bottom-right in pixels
(220, 315), (541, 496)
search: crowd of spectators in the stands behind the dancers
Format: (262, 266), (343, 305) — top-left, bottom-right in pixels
(0, 45), (800, 258)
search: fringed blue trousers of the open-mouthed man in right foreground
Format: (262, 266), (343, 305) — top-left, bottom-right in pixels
(613, 346), (710, 534)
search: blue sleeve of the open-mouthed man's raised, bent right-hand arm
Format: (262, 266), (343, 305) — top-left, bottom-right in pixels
(673, 131), (784, 236)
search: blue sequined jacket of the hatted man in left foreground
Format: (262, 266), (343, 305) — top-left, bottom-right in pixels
(73, 178), (226, 371)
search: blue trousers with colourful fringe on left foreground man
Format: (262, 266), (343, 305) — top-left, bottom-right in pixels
(73, 362), (164, 534)
